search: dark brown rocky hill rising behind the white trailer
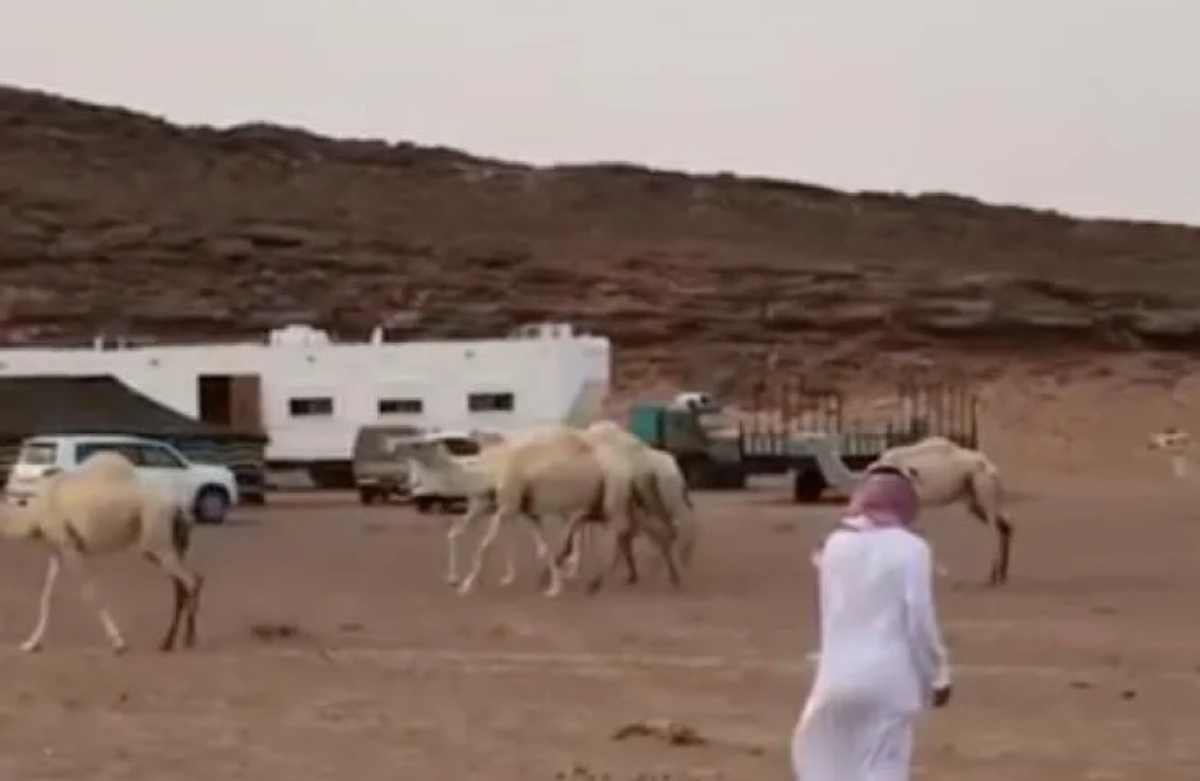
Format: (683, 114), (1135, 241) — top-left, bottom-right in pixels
(0, 88), (1200, 388)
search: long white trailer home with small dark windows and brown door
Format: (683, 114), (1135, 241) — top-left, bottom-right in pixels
(0, 323), (611, 482)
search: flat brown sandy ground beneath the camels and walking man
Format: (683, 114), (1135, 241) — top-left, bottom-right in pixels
(0, 470), (1200, 781)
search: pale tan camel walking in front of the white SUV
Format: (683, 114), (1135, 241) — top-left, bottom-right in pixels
(0, 450), (204, 654)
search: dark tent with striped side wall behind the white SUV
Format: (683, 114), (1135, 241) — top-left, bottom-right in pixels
(0, 376), (266, 503)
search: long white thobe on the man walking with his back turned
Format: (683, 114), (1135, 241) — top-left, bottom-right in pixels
(792, 518), (950, 781)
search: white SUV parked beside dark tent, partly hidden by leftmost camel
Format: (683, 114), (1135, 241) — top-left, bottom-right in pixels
(5, 434), (238, 523)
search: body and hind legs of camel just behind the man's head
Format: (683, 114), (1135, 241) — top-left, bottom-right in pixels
(868, 437), (1013, 585)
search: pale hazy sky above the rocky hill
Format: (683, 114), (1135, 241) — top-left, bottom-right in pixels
(7, 0), (1200, 224)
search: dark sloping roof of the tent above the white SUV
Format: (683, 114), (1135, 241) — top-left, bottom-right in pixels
(0, 374), (266, 440)
